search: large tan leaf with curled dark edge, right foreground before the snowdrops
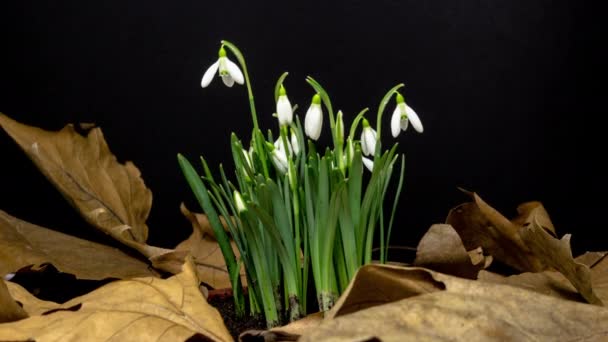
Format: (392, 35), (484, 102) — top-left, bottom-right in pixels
(300, 265), (608, 341)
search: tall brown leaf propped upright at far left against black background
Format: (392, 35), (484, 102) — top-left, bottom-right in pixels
(0, 113), (168, 257)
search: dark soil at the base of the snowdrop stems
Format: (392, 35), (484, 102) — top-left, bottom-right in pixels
(207, 293), (266, 341)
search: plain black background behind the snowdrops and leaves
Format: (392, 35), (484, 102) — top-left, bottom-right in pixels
(0, 0), (608, 255)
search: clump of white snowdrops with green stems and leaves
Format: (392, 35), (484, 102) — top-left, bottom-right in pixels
(178, 41), (423, 327)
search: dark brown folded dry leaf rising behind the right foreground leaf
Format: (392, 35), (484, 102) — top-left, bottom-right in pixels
(446, 193), (553, 272)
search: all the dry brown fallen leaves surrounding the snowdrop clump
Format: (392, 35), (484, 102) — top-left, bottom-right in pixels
(0, 114), (608, 341)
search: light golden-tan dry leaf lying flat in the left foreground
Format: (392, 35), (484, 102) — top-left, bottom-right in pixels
(0, 258), (232, 341)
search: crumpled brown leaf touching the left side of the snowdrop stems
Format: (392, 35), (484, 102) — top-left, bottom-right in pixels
(150, 203), (247, 289)
